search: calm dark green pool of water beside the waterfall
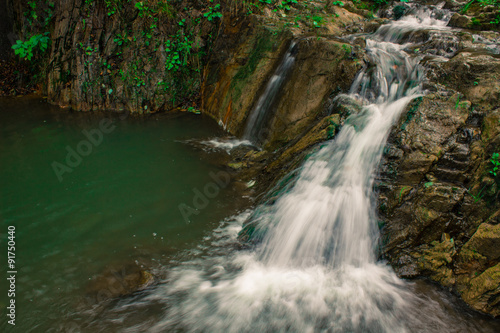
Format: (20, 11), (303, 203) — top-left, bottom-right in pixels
(0, 99), (238, 332)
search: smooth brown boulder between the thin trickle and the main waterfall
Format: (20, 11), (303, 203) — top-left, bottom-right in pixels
(266, 39), (364, 150)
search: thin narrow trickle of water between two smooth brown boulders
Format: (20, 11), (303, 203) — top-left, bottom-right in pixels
(243, 41), (297, 144)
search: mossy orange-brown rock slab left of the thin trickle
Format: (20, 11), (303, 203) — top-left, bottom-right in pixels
(201, 21), (291, 134)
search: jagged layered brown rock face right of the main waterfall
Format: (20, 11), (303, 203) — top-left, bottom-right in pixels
(377, 27), (500, 316)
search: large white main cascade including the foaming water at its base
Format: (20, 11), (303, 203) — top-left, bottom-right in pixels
(138, 5), (496, 332)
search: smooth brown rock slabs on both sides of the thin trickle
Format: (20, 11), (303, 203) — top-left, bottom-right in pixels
(202, 8), (364, 147)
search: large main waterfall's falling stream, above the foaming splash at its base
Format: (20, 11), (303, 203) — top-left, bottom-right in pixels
(254, 6), (446, 267)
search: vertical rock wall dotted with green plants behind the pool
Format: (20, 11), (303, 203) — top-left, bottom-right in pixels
(9, 0), (220, 113)
